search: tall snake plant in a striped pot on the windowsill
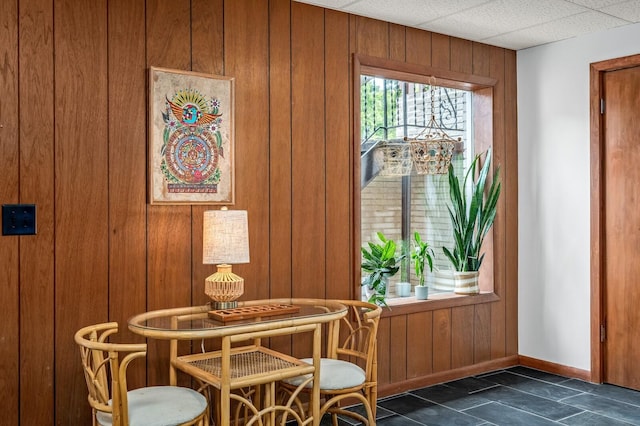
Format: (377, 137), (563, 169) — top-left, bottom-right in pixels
(442, 149), (501, 294)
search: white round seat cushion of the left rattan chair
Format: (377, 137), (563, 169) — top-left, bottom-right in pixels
(96, 386), (207, 426)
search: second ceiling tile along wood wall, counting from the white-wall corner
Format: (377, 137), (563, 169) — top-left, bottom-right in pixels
(420, 0), (586, 40)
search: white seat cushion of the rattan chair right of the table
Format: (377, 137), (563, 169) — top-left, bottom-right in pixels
(283, 358), (365, 390)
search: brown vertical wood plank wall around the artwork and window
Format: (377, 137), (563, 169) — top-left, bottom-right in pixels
(0, 0), (517, 425)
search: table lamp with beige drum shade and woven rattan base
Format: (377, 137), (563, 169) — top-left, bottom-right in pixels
(202, 207), (249, 309)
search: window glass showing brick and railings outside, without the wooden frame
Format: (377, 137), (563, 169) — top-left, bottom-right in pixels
(360, 75), (474, 297)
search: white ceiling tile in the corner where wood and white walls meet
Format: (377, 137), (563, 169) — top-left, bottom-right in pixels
(482, 11), (628, 50)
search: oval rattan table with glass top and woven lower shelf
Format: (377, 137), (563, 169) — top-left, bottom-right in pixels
(128, 298), (348, 426)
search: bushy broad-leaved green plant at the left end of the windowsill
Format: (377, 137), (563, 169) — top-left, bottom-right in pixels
(360, 232), (404, 306)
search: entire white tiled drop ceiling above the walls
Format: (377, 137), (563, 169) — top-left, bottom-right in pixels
(296, 0), (640, 50)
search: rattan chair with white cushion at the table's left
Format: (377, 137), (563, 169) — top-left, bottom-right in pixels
(75, 322), (209, 426)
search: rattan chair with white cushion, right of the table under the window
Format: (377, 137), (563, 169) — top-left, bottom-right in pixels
(282, 300), (382, 426)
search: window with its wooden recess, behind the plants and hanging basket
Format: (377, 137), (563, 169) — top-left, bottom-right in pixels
(354, 57), (493, 302)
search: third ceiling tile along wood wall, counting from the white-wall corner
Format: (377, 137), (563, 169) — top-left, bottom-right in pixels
(343, 0), (487, 26)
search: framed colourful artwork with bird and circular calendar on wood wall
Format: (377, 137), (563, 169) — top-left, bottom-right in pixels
(149, 67), (235, 205)
